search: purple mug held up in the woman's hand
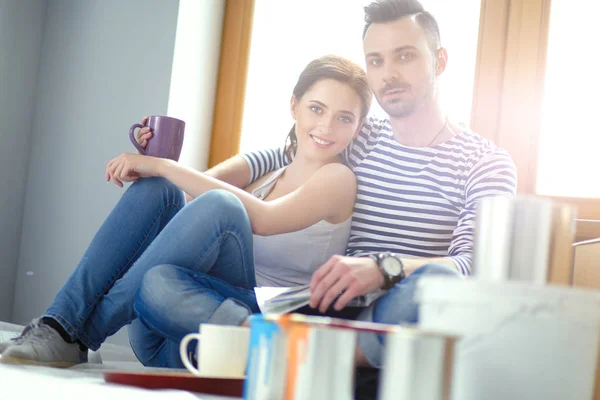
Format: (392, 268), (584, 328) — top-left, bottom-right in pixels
(129, 115), (185, 161)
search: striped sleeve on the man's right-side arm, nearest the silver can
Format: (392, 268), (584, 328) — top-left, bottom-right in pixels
(448, 149), (517, 275)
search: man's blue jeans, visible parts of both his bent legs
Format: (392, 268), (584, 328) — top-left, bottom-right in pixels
(137, 264), (461, 367)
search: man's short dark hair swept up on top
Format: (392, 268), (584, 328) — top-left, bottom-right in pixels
(363, 0), (441, 53)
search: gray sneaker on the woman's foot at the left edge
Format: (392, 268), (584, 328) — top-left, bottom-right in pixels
(0, 320), (87, 368)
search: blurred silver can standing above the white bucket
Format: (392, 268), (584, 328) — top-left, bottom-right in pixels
(473, 197), (576, 285)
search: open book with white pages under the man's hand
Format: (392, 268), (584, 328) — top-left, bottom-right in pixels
(254, 285), (385, 314)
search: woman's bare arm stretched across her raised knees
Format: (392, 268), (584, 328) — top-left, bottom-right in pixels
(107, 154), (356, 236)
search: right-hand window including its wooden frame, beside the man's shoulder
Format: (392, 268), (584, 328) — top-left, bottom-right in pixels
(472, 0), (600, 231)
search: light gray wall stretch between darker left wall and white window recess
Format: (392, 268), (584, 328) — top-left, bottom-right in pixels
(9, 0), (179, 344)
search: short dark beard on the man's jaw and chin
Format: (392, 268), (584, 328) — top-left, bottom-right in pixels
(375, 75), (435, 118)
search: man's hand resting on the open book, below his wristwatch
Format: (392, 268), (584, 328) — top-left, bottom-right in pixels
(309, 256), (384, 313)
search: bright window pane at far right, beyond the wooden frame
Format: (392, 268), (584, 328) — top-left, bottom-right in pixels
(536, 0), (600, 198)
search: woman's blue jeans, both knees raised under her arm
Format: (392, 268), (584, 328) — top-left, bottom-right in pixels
(42, 178), (255, 362)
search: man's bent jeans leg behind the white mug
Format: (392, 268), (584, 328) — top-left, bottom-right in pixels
(129, 265), (260, 368)
